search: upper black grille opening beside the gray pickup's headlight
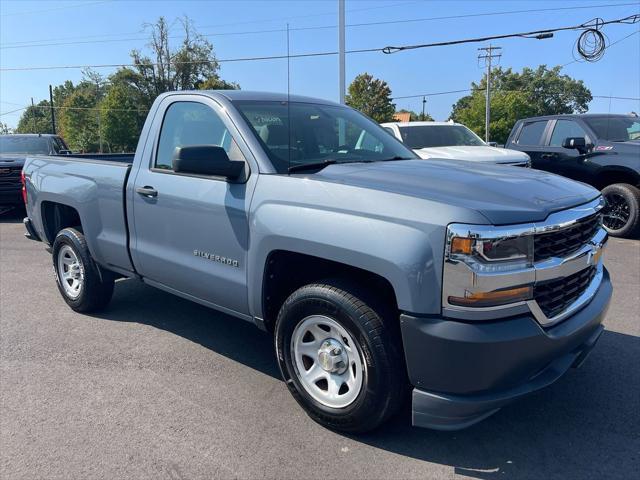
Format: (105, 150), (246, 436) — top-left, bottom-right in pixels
(533, 214), (600, 262)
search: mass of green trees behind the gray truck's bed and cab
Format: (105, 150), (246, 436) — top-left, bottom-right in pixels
(16, 17), (240, 151)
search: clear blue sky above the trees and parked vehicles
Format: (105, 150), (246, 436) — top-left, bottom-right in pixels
(0, 0), (640, 126)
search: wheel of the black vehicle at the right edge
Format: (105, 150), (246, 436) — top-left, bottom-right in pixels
(602, 183), (640, 238)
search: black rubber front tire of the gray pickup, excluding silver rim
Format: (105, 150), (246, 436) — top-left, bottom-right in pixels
(275, 280), (408, 433)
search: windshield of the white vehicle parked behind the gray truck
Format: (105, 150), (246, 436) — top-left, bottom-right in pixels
(399, 125), (485, 149)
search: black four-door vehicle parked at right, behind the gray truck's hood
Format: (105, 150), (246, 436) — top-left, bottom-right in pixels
(505, 114), (640, 237)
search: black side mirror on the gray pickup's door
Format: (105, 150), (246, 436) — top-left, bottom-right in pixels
(171, 145), (244, 179)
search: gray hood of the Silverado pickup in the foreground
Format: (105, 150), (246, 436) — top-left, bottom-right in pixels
(313, 160), (600, 225)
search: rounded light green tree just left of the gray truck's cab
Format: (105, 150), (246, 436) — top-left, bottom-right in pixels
(100, 83), (146, 152)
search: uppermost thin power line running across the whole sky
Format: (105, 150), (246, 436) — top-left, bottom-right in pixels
(0, 3), (637, 49)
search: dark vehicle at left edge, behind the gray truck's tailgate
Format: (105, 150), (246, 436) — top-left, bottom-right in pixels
(0, 134), (69, 205)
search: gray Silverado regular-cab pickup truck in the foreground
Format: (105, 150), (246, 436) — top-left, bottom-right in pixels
(24, 91), (612, 432)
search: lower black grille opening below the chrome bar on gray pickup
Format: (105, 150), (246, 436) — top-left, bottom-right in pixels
(533, 267), (597, 318)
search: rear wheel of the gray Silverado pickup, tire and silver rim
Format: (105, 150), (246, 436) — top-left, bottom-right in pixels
(52, 228), (114, 312)
